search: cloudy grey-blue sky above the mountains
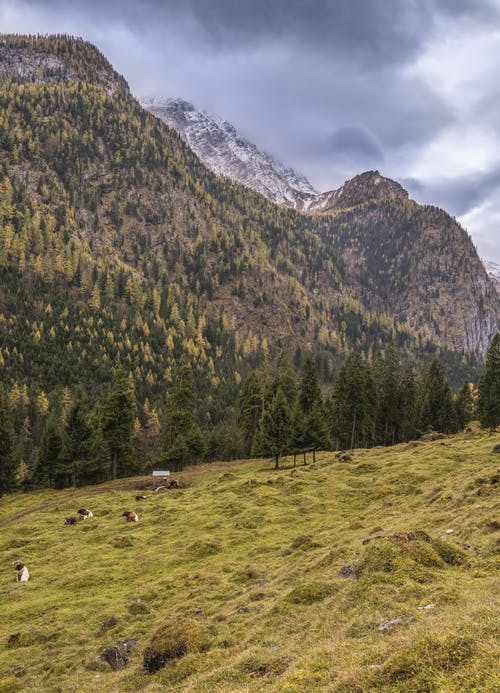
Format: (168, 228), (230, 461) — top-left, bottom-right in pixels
(0, 0), (500, 264)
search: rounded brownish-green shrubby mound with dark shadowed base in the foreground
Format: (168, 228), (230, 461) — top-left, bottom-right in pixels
(144, 618), (210, 673)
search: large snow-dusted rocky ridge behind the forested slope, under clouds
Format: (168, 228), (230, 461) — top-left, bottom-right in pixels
(140, 97), (318, 209)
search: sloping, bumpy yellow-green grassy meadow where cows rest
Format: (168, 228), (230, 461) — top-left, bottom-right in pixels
(0, 428), (500, 693)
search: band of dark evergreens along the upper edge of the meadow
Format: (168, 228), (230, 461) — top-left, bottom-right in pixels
(0, 334), (500, 494)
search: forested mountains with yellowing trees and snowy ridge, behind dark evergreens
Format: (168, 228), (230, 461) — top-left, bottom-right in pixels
(0, 35), (499, 454)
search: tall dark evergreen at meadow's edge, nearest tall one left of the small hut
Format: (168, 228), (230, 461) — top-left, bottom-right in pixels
(101, 366), (135, 479)
